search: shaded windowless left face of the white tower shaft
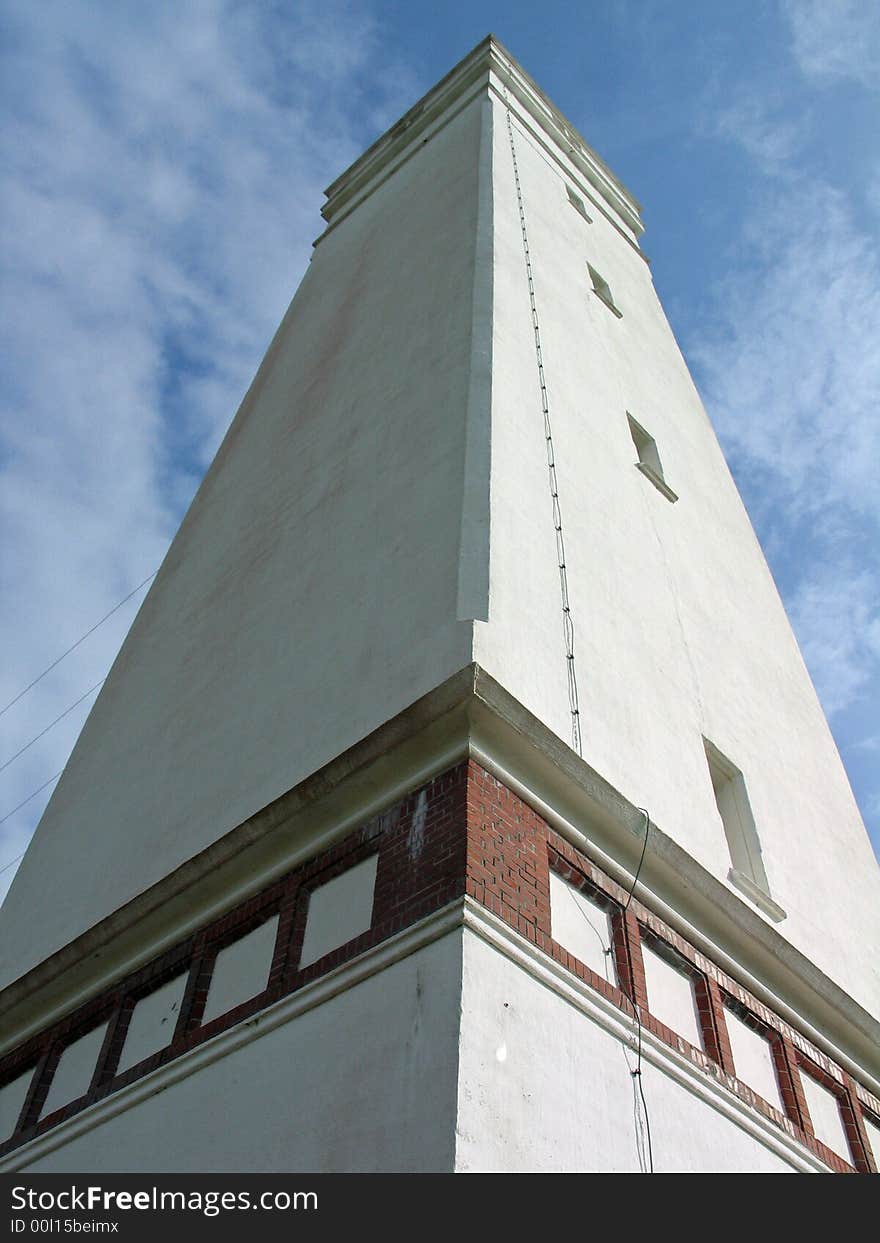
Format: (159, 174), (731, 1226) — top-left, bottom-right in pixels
(0, 101), (484, 986)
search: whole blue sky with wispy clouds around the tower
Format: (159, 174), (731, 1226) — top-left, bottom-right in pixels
(0, 0), (880, 895)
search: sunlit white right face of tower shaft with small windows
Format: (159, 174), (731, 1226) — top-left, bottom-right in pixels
(475, 90), (880, 1013)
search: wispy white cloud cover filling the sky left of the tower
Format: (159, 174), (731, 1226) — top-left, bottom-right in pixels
(0, 0), (415, 894)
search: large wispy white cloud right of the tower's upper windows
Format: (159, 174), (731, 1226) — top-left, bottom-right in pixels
(691, 179), (880, 523)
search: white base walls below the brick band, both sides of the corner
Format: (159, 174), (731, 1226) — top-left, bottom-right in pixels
(5, 927), (820, 1173)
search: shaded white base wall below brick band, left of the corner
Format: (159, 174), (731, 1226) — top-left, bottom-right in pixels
(22, 932), (461, 1173)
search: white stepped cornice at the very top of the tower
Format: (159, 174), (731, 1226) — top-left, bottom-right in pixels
(321, 35), (644, 240)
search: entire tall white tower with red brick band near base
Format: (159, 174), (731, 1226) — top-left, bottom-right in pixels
(0, 37), (880, 1172)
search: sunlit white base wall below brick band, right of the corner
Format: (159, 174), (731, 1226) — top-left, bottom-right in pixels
(455, 932), (789, 1173)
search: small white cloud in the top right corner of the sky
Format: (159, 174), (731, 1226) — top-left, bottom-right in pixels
(782, 0), (880, 91)
